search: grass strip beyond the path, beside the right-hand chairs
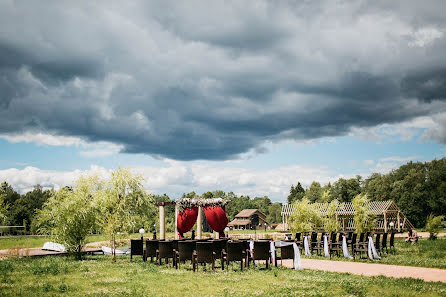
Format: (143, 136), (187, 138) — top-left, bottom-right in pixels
(302, 237), (446, 269)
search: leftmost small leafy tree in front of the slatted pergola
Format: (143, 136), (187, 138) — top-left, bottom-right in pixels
(288, 198), (322, 233)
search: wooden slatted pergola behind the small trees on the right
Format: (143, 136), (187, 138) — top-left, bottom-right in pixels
(281, 201), (413, 232)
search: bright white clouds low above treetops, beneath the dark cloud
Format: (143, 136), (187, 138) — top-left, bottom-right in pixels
(0, 160), (340, 202)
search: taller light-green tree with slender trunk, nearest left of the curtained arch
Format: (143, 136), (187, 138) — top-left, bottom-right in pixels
(97, 168), (155, 261)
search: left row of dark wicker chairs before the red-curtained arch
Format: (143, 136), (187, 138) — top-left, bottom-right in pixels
(130, 238), (271, 271)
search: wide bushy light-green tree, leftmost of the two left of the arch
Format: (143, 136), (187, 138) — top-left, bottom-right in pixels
(37, 176), (100, 259)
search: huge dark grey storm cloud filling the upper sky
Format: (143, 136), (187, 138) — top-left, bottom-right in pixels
(0, 1), (446, 160)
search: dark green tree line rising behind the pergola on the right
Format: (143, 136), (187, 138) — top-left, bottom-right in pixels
(287, 158), (446, 227)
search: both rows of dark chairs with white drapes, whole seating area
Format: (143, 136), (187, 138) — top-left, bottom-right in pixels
(130, 231), (395, 272)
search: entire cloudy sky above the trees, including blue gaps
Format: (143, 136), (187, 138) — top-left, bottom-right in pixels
(0, 0), (446, 202)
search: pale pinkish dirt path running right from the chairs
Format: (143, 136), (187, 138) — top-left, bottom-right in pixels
(278, 259), (446, 283)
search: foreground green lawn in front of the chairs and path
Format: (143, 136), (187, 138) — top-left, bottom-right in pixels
(0, 256), (446, 297)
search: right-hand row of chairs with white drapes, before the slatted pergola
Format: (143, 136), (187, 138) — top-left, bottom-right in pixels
(295, 232), (395, 258)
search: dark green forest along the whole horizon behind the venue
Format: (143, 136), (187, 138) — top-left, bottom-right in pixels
(0, 158), (446, 233)
